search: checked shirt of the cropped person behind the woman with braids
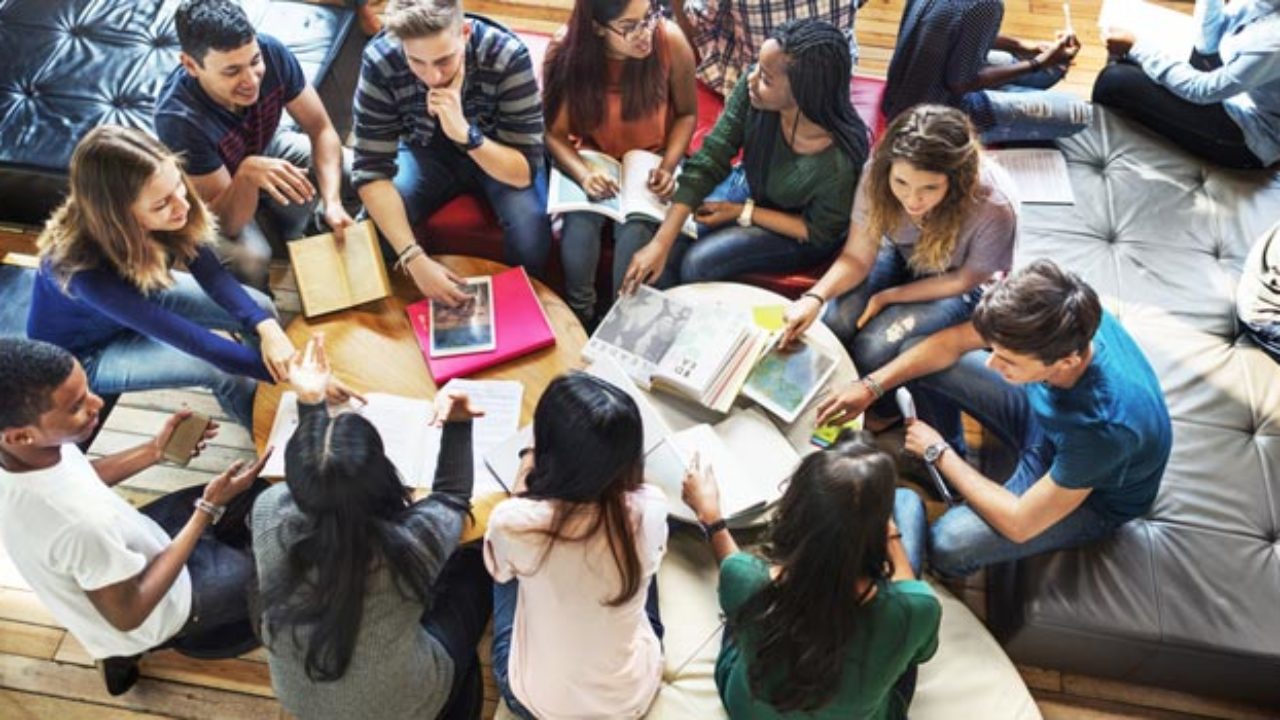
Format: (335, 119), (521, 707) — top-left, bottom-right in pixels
(685, 0), (865, 96)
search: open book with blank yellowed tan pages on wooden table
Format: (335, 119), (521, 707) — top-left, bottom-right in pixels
(288, 220), (392, 318)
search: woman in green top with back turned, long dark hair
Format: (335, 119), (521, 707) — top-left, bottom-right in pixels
(684, 432), (942, 720)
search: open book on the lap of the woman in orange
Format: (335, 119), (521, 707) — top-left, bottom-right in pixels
(547, 150), (698, 238)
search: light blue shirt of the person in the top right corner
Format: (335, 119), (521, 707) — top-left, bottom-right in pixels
(1129, 0), (1280, 165)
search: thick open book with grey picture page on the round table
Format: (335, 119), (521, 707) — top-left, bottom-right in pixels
(582, 286), (776, 413)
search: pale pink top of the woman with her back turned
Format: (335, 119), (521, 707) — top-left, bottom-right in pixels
(485, 484), (667, 720)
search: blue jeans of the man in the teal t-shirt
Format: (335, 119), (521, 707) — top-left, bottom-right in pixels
(910, 350), (1120, 577)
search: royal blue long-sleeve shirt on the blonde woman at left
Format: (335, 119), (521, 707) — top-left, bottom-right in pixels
(27, 246), (271, 380)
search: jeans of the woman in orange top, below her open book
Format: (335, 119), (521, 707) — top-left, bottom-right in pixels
(561, 213), (658, 324)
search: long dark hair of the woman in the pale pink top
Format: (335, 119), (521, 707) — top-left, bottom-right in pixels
(525, 373), (644, 606)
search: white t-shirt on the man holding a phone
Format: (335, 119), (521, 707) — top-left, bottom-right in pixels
(0, 445), (191, 659)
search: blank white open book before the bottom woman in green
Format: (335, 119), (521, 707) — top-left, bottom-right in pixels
(644, 407), (800, 523)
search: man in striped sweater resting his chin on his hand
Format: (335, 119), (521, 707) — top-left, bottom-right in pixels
(352, 0), (550, 305)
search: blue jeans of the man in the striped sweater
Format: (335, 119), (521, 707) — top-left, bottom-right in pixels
(393, 132), (552, 277)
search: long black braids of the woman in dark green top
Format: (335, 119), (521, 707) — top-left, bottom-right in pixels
(742, 18), (869, 193)
